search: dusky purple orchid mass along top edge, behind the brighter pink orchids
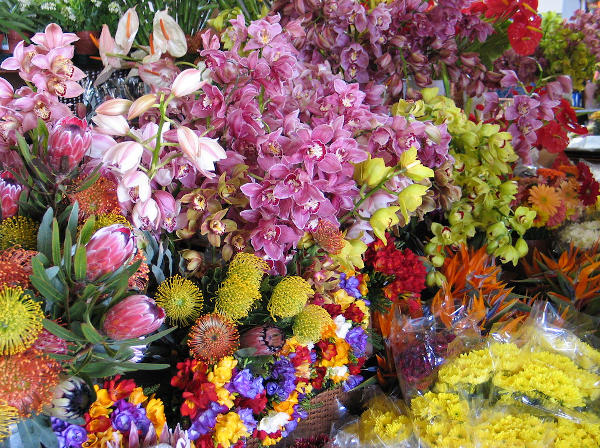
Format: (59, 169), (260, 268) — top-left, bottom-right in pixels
(274, 0), (497, 99)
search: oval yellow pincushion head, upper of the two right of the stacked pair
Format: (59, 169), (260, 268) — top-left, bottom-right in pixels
(267, 275), (315, 320)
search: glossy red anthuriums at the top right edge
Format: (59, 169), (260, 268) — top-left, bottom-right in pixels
(478, 0), (542, 56)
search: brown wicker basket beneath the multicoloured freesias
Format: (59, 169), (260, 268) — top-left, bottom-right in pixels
(246, 387), (358, 448)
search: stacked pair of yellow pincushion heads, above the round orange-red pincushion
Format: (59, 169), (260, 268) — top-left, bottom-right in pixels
(215, 252), (269, 321)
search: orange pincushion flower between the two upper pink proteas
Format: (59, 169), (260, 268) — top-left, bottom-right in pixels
(69, 177), (120, 219)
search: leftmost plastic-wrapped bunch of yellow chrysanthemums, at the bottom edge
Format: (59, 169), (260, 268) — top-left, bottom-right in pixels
(332, 388), (418, 448)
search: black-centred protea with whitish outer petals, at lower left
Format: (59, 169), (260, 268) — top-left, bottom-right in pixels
(46, 376), (92, 420)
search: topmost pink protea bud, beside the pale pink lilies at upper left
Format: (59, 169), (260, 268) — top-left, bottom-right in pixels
(48, 117), (92, 173)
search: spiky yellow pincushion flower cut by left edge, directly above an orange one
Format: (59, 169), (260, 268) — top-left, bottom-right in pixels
(0, 286), (44, 356)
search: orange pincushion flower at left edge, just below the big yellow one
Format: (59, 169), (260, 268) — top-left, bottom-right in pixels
(0, 349), (61, 417)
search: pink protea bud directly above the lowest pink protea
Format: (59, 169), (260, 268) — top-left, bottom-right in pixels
(85, 224), (135, 281)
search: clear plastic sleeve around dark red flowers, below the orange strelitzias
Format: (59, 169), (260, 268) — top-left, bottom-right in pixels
(388, 310), (481, 403)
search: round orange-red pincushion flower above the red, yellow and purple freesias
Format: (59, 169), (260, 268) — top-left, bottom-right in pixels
(188, 313), (240, 363)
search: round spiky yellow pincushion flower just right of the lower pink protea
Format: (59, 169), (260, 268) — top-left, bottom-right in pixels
(155, 275), (204, 325)
